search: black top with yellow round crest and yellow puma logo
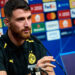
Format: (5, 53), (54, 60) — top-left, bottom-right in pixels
(0, 34), (46, 75)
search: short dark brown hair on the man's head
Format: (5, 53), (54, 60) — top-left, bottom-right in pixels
(4, 0), (30, 17)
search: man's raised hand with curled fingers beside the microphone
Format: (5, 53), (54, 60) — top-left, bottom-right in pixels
(36, 56), (56, 75)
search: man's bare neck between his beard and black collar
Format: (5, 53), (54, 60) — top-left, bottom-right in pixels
(8, 31), (25, 46)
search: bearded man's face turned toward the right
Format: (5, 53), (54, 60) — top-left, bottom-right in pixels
(8, 9), (32, 39)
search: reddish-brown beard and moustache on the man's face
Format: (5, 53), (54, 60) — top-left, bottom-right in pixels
(10, 24), (31, 40)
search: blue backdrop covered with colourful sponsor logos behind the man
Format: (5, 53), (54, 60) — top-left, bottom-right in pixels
(0, 0), (75, 75)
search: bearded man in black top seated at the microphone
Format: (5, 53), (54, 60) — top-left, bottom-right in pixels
(0, 0), (55, 75)
